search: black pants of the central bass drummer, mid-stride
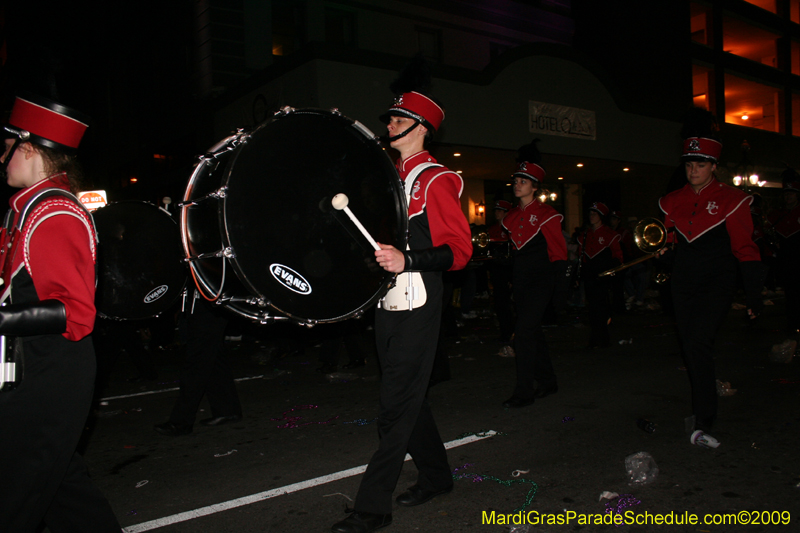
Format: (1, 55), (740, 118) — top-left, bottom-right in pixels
(354, 281), (453, 514)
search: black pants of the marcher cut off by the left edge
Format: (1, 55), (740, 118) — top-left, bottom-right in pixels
(0, 335), (120, 533)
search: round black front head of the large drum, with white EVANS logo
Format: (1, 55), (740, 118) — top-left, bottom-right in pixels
(221, 110), (408, 322)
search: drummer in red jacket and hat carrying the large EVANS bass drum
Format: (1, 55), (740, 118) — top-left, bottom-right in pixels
(331, 82), (472, 533)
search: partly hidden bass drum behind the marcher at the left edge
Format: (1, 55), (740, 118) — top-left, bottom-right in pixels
(92, 201), (187, 320)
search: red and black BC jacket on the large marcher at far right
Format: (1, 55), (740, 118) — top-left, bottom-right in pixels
(658, 179), (764, 309)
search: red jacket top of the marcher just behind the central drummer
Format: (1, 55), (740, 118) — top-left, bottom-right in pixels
(501, 198), (567, 263)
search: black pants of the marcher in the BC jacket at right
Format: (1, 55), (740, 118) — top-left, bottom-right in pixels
(672, 269), (736, 427)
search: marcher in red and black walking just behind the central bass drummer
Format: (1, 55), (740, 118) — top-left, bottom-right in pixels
(502, 141), (567, 408)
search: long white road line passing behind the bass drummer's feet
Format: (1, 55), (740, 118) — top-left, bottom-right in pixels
(123, 431), (497, 533)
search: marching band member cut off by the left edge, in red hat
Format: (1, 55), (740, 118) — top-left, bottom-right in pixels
(0, 98), (120, 533)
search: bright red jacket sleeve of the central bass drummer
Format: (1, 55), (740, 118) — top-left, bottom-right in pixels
(425, 171), (472, 270)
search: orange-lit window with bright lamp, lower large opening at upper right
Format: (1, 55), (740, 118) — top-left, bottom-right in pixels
(725, 74), (785, 133)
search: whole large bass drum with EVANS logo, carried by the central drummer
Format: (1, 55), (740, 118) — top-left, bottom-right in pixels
(180, 108), (408, 325)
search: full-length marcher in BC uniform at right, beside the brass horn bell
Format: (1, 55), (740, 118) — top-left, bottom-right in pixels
(659, 113), (763, 431)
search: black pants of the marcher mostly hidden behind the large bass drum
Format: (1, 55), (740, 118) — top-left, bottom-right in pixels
(169, 299), (242, 425)
